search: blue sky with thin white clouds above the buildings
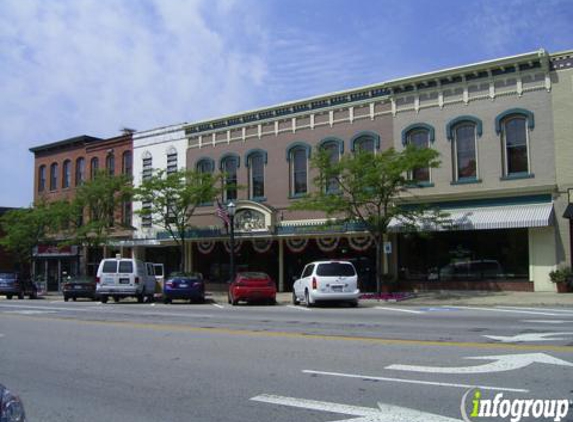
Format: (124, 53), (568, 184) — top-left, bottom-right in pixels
(0, 0), (573, 206)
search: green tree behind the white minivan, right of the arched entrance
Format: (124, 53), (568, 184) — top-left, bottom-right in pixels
(291, 146), (443, 293)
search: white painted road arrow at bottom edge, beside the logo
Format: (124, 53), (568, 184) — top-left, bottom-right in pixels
(251, 394), (461, 422)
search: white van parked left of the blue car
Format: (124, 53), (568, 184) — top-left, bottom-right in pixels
(96, 257), (155, 303)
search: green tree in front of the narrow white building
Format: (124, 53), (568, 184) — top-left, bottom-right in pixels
(134, 170), (221, 271)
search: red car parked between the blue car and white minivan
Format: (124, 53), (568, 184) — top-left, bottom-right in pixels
(228, 272), (277, 306)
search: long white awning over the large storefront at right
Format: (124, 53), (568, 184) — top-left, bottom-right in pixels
(389, 203), (553, 231)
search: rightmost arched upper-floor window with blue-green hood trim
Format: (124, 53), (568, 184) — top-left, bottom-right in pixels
(495, 109), (535, 177)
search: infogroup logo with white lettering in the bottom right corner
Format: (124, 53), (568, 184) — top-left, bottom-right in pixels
(460, 389), (571, 422)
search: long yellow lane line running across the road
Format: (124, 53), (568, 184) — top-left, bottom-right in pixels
(3, 314), (573, 353)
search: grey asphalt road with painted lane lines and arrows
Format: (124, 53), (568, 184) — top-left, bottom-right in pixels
(0, 299), (573, 422)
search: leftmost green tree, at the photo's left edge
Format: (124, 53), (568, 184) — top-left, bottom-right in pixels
(0, 202), (54, 272)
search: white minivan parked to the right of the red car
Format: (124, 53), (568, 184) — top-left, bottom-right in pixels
(292, 261), (360, 307)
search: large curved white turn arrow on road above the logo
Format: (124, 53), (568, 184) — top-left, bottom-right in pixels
(386, 353), (573, 374)
